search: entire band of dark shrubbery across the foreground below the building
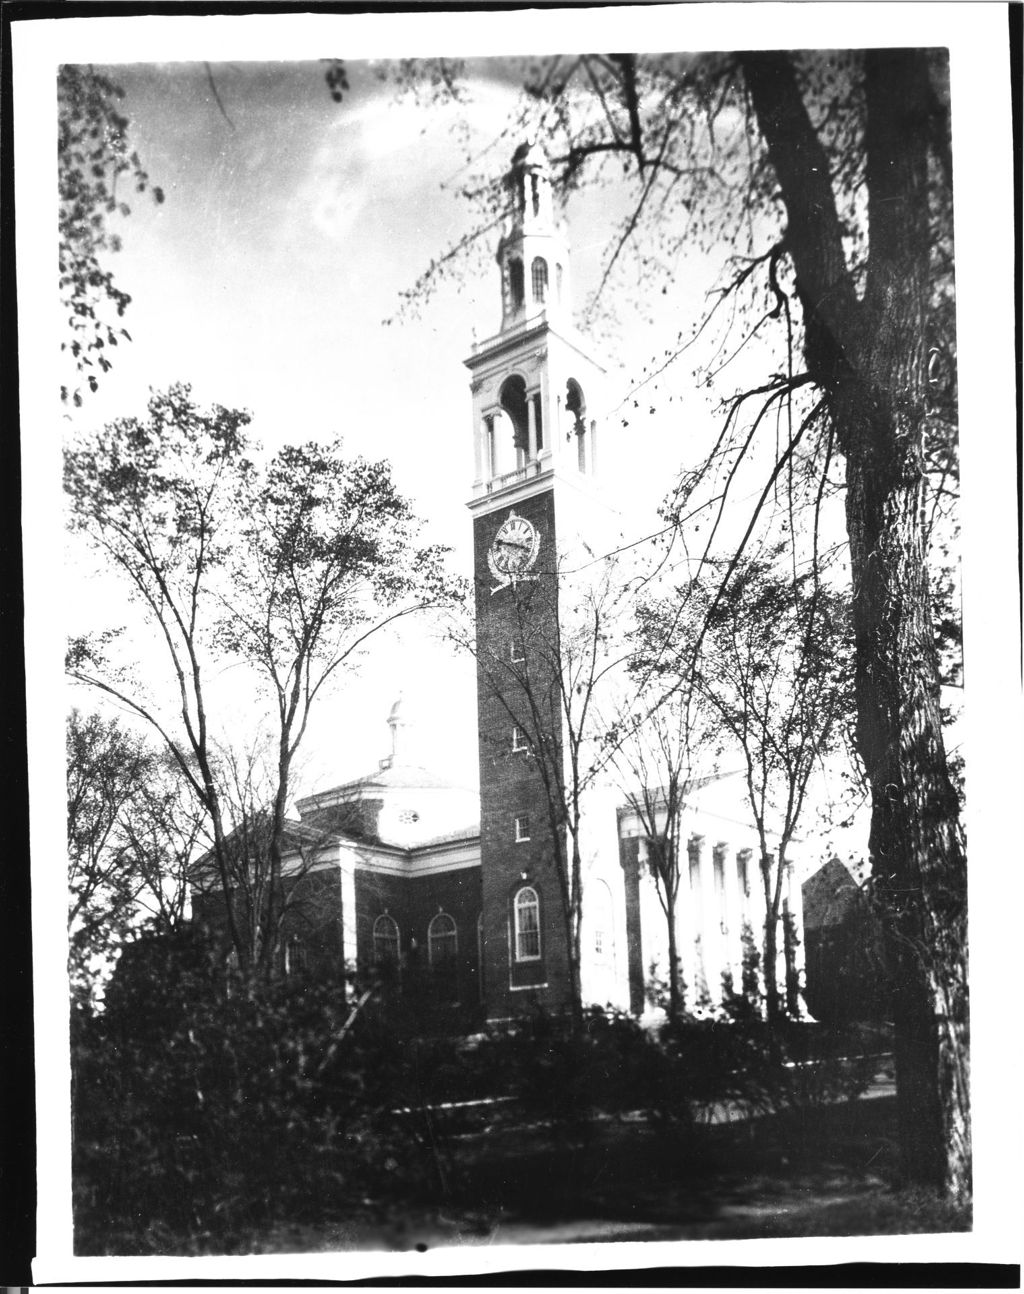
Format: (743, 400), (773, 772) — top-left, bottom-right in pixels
(72, 929), (890, 1253)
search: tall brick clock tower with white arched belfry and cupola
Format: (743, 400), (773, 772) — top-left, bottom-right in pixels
(465, 144), (615, 1020)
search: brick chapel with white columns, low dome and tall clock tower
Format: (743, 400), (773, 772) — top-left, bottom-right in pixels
(190, 145), (800, 1031)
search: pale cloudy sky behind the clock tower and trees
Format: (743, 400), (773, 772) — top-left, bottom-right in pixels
(55, 60), (711, 792)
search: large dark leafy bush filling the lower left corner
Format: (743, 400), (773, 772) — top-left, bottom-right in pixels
(72, 932), (453, 1253)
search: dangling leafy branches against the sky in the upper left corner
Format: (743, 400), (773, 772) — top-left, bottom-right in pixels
(57, 63), (163, 405)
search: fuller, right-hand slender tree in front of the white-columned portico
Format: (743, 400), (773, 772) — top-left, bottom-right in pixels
(632, 550), (853, 1017)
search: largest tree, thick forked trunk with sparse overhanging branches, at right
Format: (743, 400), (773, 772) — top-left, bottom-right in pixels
(401, 49), (971, 1196)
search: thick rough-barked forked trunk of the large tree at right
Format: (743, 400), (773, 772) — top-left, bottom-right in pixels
(744, 50), (971, 1197)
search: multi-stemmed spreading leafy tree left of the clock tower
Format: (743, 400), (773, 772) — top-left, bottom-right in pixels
(65, 386), (447, 974)
